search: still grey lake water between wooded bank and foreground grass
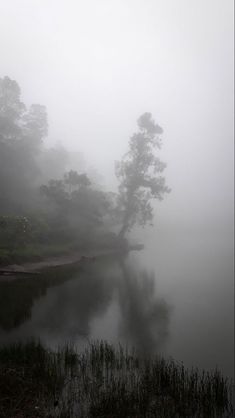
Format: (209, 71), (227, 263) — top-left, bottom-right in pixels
(0, 225), (234, 376)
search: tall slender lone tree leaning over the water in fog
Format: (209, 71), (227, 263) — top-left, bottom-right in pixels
(116, 113), (170, 238)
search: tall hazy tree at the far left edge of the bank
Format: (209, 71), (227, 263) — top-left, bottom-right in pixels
(0, 77), (47, 214)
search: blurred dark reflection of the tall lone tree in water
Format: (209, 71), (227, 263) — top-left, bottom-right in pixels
(119, 263), (170, 355)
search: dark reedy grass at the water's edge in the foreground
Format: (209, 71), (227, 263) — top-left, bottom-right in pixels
(0, 341), (233, 418)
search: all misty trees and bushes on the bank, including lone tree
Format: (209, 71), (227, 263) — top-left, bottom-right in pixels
(0, 77), (169, 264)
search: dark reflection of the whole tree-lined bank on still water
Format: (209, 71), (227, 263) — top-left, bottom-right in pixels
(0, 257), (169, 354)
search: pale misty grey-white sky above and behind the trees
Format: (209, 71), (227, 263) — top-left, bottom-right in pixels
(0, 0), (233, 229)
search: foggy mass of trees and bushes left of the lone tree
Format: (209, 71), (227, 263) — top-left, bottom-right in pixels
(0, 77), (120, 262)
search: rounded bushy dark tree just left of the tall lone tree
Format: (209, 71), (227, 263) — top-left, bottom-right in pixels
(40, 170), (109, 241)
